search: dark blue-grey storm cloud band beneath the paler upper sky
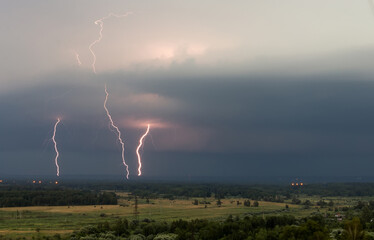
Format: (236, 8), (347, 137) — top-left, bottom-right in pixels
(0, 66), (374, 176)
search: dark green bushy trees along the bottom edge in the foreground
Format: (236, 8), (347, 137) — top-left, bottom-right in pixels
(65, 216), (373, 240)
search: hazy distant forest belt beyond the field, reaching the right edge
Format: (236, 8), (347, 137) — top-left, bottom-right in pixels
(61, 182), (374, 202)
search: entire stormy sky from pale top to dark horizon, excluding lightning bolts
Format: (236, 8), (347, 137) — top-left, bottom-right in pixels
(0, 0), (374, 178)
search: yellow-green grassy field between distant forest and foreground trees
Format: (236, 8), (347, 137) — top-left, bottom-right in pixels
(0, 193), (370, 237)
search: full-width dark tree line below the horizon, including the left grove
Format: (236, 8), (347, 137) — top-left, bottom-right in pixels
(0, 181), (374, 207)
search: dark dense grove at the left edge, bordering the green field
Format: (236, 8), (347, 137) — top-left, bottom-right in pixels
(0, 186), (117, 207)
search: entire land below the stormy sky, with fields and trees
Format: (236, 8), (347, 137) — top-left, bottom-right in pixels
(0, 180), (374, 239)
